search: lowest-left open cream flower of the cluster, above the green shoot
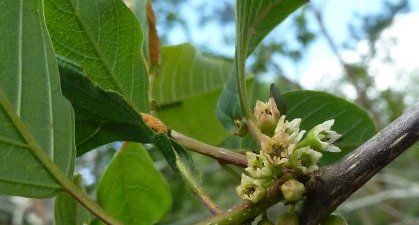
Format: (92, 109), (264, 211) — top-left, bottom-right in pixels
(236, 174), (266, 203)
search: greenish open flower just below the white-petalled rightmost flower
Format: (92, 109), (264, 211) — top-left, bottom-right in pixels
(288, 146), (322, 173)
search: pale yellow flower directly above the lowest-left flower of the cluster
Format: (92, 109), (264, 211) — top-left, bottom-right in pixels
(245, 152), (273, 178)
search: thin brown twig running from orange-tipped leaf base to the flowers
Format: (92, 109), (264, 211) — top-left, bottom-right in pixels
(170, 130), (247, 167)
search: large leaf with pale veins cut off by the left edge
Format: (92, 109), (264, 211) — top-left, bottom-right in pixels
(0, 0), (75, 197)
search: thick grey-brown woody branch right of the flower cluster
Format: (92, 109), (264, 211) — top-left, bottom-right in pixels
(299, 103), (419, 225)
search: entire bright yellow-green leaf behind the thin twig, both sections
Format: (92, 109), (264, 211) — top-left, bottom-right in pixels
(153, 44), (232, 144)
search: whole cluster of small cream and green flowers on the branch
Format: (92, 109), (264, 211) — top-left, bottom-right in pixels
(236, 98), (341, 203)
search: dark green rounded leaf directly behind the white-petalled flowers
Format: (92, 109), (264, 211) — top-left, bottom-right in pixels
(282, 91), (376, 165)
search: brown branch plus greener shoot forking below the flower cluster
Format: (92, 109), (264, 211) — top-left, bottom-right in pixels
(196, 103), (419, 225)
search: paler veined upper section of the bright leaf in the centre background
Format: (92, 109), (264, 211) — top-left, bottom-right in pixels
(153, 44), (233, 104)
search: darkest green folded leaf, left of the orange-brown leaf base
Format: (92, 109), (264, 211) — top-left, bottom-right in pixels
(57, 56), (153, 155)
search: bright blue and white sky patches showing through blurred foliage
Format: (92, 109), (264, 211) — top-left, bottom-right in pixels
(162, 0), (419, 96)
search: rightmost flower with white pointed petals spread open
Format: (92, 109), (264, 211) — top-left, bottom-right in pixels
(297, 120), (342, 152)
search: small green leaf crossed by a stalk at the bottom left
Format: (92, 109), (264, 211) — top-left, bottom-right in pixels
(54, 175), (92, 225)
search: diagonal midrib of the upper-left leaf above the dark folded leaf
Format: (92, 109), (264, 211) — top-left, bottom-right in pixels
(66, 0), (126, 99)
